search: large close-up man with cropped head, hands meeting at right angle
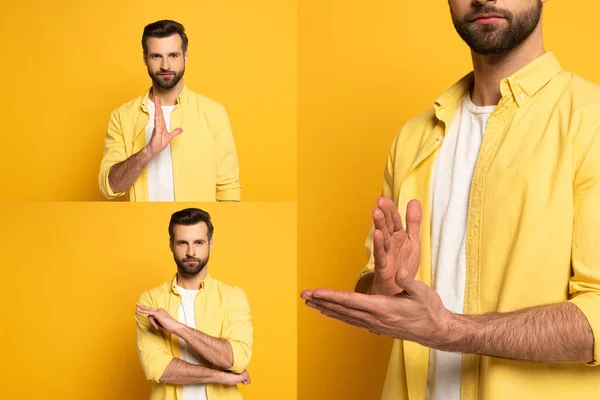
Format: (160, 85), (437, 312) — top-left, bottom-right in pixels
(302, 0), (600, 400)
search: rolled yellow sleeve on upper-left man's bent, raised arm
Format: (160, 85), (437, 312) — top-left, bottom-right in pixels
(98, 110), (127, 200)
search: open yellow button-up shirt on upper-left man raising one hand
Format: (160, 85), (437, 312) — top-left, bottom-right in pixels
(98, 86), (241, 201)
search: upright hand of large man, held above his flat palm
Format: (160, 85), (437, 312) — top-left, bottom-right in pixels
(371, 197), (422, 296)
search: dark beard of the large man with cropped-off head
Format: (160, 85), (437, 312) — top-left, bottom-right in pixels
(450, 1), (542, 55)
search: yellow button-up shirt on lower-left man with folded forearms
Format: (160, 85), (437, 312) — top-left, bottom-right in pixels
(135, 275), (253, 400)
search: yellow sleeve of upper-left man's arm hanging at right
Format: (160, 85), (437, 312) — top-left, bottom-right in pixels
(215, 107), (242, 201)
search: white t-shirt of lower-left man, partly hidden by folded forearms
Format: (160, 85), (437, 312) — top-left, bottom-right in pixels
(177, 286), (207, 400)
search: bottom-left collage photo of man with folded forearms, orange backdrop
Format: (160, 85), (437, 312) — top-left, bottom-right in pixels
(0, 202), (297, 400)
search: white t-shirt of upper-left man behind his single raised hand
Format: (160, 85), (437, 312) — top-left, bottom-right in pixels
(146, 99), (175, 201)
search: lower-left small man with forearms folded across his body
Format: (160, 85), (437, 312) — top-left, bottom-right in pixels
(135, 208), (253, 400)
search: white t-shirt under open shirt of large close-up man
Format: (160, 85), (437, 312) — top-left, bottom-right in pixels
(427, 95), (496, 400)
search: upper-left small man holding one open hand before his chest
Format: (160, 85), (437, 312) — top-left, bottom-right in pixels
(98, 20), (241, 201)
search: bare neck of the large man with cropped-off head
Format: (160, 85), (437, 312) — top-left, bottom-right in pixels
(471, 21), (545, 106)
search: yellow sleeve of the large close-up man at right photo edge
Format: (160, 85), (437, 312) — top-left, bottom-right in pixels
(569, 129), (600, 366)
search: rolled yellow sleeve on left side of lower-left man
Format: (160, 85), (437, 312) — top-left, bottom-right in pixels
(135, 293), (173, 382)
